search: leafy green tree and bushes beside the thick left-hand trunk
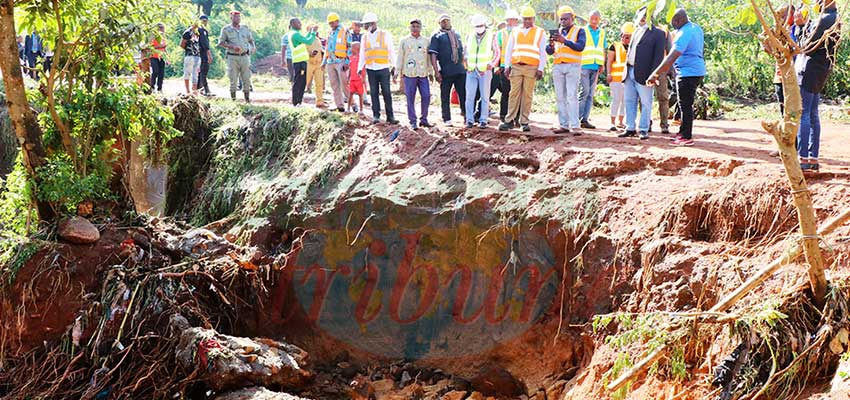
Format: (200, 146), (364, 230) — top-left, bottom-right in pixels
(0, 0), (181, 223)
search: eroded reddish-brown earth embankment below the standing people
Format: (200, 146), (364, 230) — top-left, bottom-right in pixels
(0, 100), (850, 400)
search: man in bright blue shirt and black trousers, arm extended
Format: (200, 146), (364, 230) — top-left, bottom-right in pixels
(647, 8), (705, 146)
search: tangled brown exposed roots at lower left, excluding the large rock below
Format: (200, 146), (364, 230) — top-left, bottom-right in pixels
(0, 223), (270, 399)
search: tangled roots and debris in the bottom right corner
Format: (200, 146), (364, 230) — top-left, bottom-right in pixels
(713, 284), (850, 400)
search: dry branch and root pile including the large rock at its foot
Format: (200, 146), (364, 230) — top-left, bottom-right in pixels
(0, 220), (310, 399)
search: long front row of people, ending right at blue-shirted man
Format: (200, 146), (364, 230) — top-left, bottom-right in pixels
(255, 7), (706, 146)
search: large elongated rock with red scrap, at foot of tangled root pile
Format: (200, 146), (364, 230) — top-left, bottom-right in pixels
(172, 318), (313, 390)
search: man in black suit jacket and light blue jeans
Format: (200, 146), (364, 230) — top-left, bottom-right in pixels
(618, 7), (667, 140)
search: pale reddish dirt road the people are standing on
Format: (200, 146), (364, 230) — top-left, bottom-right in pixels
(164, 78), (850, 175)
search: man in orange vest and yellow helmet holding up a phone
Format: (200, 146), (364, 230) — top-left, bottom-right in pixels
(546, 6), (586, 136)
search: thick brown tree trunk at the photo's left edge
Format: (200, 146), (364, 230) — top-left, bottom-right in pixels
(0, 0), (55, 220)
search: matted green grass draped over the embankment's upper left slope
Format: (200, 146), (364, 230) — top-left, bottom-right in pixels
(192, 101), (355, 224)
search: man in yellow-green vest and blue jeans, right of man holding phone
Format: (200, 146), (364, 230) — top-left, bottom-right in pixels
(578, 10), (608, 129)
